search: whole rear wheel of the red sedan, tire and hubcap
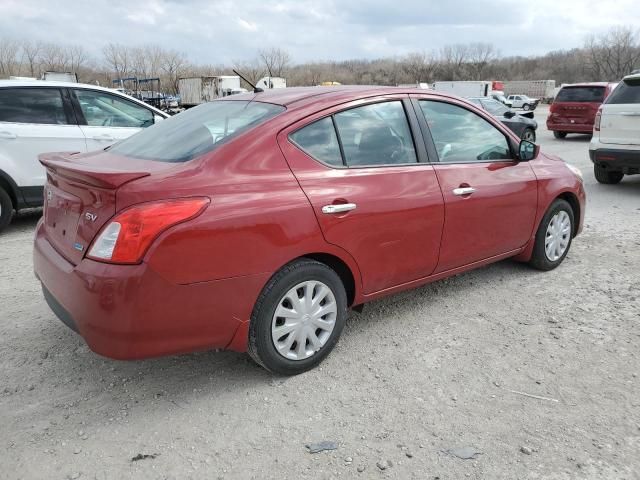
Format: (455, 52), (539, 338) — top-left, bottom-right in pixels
(249, 259), (347, 375)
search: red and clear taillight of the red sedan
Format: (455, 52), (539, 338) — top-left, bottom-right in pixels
(87, 198), (209, 264)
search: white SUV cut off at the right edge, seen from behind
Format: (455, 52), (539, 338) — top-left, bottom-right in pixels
(589, 74), (640, 183)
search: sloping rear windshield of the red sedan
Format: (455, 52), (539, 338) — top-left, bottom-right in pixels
(110, 101), (285, 162)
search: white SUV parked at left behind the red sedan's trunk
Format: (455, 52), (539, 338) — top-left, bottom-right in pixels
(0, 80), (168, 230)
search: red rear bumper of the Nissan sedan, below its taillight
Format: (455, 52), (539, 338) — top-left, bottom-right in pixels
(33, 222), (269, 359)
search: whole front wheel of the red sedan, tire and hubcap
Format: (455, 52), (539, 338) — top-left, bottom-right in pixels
(529, 198), (575, 271)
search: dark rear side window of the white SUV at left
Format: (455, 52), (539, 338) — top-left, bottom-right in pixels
(0, 88), (68, 125)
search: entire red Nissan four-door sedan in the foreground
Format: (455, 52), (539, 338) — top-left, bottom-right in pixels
(34, 87), (585, 374)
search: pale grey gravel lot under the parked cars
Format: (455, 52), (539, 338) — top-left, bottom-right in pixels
(0, 106), (640, 480)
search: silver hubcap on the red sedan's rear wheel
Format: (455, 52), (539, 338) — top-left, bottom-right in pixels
(271, 281), (338, 360)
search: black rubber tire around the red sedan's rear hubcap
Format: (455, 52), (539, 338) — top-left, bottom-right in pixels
(248, 258), (347, 375)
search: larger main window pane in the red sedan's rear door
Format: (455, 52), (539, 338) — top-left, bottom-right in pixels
(334, 101), (418, 167)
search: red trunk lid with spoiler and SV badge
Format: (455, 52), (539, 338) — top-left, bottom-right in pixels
(39, 152), (167, 265)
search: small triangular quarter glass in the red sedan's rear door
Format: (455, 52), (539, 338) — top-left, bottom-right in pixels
(289, 117), (343, 167)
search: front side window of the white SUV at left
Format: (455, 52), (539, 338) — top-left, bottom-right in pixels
(75, 90), (153, 128)
